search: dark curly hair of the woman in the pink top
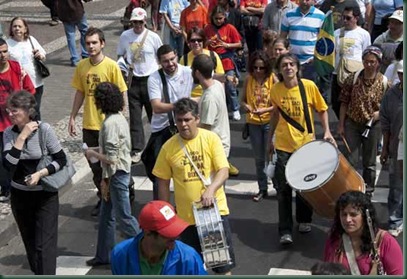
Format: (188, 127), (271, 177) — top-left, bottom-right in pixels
(331, 191), (378, 253)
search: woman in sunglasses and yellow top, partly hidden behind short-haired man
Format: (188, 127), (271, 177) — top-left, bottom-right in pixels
(179, 27), (225, 97)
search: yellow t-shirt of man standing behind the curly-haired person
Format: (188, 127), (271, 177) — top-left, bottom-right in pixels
(72, 56), (127, 131)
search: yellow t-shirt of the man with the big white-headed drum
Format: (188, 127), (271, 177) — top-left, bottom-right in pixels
(271, 79), (328, 153)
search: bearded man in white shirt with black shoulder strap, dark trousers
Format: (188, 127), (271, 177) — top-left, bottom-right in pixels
(141, 45), (193, 200)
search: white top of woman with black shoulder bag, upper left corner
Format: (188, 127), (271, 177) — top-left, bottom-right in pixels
(6, 36), (46, 88)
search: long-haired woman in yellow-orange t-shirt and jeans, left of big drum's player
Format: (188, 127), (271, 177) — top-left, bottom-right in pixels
(241, 51), (274, 201)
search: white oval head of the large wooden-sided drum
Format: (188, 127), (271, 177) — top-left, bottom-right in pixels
(285, 140), (339, 192)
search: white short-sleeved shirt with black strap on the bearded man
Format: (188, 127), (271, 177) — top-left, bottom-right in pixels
(148, 64), (194, 133)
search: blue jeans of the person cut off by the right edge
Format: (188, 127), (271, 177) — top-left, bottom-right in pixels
(387, 158), (403, 229)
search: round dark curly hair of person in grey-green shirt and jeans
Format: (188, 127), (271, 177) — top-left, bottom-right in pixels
(95, 82), (124, 114)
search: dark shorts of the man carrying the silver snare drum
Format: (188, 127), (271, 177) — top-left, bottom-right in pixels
(180, 215), (236, 274)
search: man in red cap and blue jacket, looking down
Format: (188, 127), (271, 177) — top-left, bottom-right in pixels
(111, 200), (207, 275)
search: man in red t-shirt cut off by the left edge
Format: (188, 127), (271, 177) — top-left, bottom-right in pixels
(0, 38), (35, 202)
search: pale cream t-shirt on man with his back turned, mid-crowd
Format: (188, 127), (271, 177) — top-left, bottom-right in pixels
(199, 80), (230, 157)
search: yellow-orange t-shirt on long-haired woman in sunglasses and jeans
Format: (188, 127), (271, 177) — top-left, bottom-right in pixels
(245, 75), (274, 125)
